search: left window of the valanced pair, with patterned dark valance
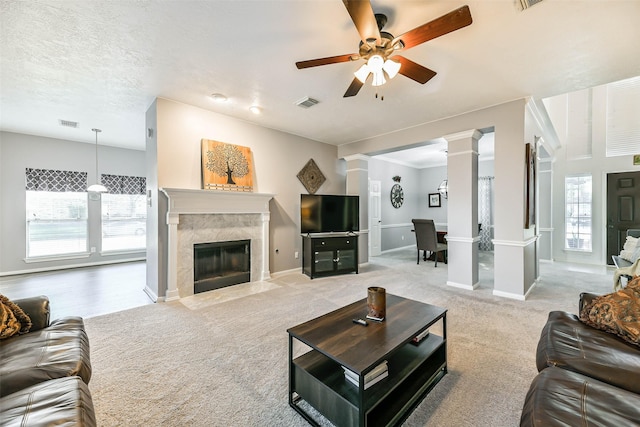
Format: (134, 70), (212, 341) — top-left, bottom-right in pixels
(26, 168), (87, 258)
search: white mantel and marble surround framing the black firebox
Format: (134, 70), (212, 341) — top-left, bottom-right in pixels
(160, 188), (273, 301)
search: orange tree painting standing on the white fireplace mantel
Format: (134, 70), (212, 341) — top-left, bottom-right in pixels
(202, 139), (253, 191)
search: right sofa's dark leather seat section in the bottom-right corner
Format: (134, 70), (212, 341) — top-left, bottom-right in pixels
(520, 367), (640, 427)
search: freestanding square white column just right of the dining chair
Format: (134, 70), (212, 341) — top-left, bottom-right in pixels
(444, 129), (482, 290)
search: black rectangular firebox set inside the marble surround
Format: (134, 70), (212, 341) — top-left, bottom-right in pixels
(193, 240), (251, 294)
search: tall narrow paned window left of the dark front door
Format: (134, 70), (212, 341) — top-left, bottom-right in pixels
(564, 175), (591, 251)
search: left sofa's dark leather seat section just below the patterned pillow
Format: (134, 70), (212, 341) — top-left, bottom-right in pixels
(0, 317), (91, 397)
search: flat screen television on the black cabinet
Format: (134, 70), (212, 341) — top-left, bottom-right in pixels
(300, 194), (360, 234)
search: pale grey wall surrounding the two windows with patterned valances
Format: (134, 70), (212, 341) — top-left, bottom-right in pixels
(0, 132), (145, 274)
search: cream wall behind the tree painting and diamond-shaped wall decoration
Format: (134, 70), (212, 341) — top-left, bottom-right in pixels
(147, 98), (346, 296)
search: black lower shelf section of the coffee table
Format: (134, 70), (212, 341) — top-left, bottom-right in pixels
(289, 334), (447, 427)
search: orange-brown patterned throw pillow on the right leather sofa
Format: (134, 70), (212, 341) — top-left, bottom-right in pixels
(580, 276), (640, 346)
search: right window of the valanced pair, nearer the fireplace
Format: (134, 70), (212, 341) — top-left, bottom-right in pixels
(102, 174), (147, 252)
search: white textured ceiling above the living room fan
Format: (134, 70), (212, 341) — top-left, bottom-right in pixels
(0, 0), (640, 149)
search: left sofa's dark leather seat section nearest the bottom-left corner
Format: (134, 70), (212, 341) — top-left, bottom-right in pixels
(0, 377), (96, 427)
